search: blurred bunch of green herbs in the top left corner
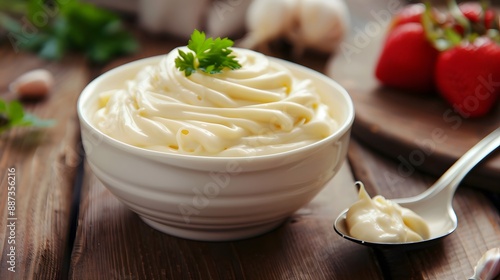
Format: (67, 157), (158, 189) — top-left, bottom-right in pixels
(0, 0), (138, 64)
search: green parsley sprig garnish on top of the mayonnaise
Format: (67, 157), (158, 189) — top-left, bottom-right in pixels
(175, 30), (241, 77)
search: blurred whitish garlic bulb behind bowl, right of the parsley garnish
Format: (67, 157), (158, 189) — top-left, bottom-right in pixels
(238, 0), (349, 55)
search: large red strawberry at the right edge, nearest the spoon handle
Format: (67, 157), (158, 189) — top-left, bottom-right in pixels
(435, 37), (500, 117)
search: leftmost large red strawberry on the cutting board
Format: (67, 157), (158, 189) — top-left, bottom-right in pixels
(375, 23), (438, 93)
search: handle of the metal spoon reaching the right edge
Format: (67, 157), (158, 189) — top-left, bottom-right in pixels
(421, 127), (500, 196)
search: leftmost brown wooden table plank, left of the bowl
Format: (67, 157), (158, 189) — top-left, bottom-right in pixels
(0, 46), (89, 279)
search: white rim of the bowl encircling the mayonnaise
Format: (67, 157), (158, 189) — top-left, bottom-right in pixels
(77, 52), (355, 162)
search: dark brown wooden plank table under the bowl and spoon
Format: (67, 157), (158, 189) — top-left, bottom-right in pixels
(0, 1), (500, 280)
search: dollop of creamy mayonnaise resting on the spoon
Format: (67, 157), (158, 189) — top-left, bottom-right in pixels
(346, 184), (430, 243)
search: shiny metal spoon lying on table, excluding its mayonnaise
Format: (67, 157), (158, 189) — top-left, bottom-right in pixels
(334, 128), (500, 249)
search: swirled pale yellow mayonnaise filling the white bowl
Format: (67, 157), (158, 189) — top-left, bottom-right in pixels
(93, 47), (337, 156)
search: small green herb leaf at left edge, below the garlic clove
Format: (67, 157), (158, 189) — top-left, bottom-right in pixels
(0, 99), (55, 134)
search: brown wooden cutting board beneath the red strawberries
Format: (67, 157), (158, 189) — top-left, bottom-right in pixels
(326, 13), (500, 192)
